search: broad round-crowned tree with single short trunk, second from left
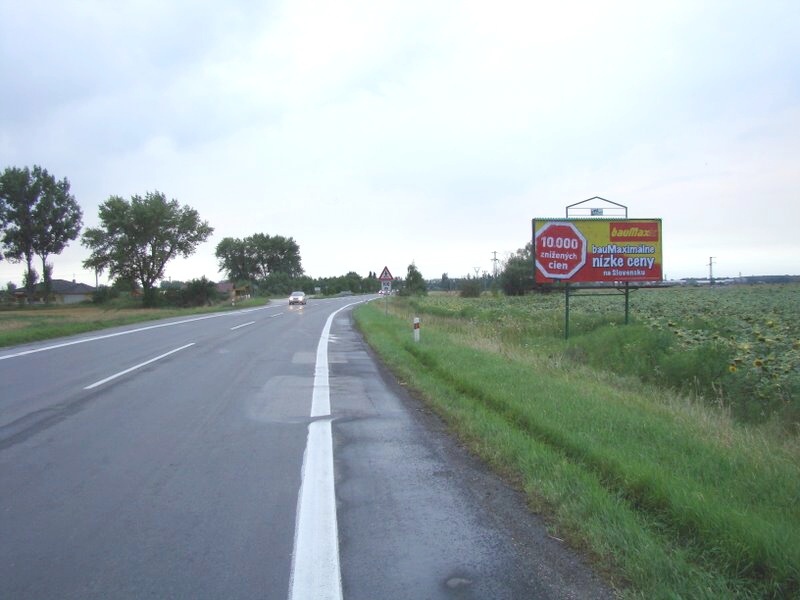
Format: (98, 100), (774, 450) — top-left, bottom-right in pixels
(82, 191), (214, 306)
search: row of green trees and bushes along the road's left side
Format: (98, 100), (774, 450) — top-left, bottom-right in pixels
(0, 166), (380, 306)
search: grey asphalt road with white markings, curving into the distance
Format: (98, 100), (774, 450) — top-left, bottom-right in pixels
(0, 298), (610, 600)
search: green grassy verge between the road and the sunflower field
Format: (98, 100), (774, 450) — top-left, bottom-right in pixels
(355, 291), (800, 598)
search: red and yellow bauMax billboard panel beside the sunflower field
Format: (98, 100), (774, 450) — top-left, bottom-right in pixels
(533, 219), (663, 283)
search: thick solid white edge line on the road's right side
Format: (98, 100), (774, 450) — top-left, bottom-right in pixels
(289, 302), (361, 600)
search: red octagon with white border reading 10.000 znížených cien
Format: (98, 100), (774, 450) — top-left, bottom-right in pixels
(535, 221), (587, 279)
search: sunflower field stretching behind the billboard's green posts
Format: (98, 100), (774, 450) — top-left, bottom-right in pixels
(412, 285), (800, 432)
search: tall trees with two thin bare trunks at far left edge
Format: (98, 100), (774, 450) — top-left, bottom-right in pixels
(0, 166), (83, 300)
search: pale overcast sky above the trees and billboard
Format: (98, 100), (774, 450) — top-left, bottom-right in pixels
(0, 0), (800, 285)
